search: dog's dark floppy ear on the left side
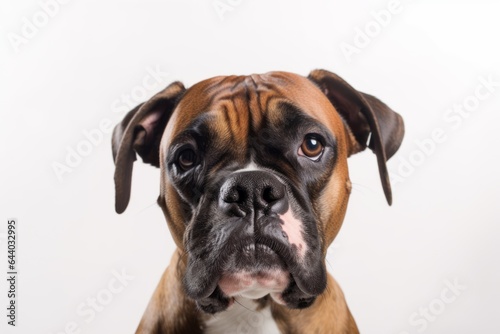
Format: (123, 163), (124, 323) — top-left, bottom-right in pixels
(111, 82), (185, 213)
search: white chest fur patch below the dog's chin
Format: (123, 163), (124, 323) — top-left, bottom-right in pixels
(205, 297), (279, 334)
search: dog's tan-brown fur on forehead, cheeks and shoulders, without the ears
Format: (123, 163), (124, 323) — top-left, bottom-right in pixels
(138, 73), (358, 333)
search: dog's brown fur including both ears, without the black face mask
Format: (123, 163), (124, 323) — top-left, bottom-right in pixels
(113, 70), (404, 334)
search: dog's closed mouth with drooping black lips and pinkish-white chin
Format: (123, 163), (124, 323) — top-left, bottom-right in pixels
(184, 236), (326, 313)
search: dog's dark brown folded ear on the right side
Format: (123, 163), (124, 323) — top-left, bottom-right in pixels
(308, 70), (404, 205)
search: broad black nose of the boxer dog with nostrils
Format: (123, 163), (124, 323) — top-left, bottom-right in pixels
(219, 171), (288, 217)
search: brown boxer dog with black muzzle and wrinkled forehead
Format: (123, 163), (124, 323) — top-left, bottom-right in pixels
(112, 70), (404, 334)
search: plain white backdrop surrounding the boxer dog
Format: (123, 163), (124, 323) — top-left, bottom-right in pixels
(0, 0), (500, 334)
